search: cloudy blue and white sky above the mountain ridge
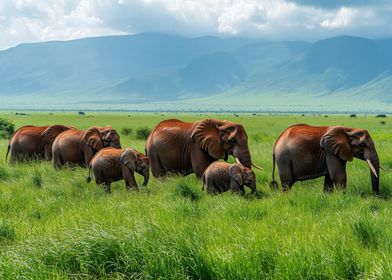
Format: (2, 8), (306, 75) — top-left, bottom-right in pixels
(0, 0), (392, 49)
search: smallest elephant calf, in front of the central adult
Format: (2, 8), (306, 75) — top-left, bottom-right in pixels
(202, 161), (256, 195)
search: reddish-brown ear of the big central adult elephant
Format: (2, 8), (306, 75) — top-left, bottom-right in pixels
(191, 119), (225, 159)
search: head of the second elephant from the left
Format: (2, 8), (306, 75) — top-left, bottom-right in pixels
(84, 126), (121, 151)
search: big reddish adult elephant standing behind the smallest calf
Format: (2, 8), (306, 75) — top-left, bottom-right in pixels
(146, 119), (258, 178)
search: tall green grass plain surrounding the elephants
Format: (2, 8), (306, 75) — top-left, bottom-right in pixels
(0, 113), (392, 279)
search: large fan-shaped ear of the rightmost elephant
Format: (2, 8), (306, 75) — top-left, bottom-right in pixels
(320, 126), (353, 161)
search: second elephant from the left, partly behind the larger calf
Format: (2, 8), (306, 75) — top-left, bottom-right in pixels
(52, 126), (121, 169)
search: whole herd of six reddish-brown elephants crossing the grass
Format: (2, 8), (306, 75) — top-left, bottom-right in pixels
(6, 119), (380, 194)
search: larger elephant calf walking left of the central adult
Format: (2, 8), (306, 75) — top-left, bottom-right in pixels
(87, 147), (150, 192)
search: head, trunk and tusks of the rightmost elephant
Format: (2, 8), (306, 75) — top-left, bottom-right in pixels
(320, 126), (380, 194)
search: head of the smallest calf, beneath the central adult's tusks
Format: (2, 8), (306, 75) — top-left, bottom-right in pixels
(229, 163), (256, 193)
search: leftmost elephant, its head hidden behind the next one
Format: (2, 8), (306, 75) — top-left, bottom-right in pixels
(5, 125), (73, 163)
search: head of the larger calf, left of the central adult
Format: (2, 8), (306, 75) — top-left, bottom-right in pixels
(120, 149), (150, 186)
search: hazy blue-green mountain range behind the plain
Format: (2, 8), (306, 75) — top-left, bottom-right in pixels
(0, 33), (392, 110)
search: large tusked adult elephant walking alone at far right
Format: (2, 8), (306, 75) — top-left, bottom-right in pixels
(270, 124), (380, 195)
